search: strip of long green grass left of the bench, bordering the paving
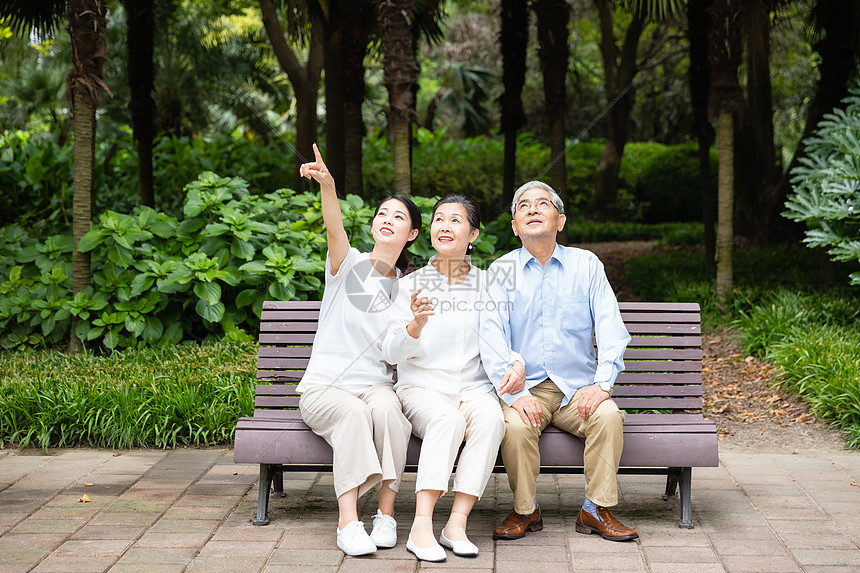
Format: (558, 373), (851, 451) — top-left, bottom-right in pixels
(0, 342), (257, 448)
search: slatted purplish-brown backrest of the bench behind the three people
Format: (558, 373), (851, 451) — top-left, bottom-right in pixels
(254, 301), (702, 423)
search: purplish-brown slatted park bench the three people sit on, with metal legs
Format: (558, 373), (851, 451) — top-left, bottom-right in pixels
(234, 301), (719, 528)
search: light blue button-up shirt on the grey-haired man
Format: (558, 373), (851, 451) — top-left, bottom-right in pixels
(481, 245), (630, 407)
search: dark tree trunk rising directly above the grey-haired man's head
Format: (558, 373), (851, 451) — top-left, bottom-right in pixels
(533, 0), (570, 210)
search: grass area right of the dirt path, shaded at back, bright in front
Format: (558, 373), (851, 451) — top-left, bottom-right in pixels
(627, 246), (860, 448)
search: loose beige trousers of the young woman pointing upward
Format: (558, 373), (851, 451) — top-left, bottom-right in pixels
(299, 384), (412, 497)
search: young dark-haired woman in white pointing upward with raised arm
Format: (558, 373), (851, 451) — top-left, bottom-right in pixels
(297, 145), (421, 555)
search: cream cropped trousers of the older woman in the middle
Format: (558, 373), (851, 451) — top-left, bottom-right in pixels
(397, 387), (505, 498)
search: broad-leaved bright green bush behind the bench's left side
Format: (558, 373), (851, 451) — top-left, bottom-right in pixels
(0, 172), (508, 349)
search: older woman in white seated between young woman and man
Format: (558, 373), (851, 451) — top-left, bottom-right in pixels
(382, 195), (505, 561)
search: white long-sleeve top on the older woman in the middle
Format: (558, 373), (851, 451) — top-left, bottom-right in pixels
(382, 257), (494, 402)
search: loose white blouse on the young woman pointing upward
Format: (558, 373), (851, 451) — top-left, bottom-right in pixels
(296, 247), (400, 393)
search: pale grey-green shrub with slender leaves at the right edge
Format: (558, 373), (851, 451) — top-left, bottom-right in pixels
(783, 82), (860, 285)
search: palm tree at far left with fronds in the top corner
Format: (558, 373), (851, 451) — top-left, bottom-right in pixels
(0, 0), (108, 352)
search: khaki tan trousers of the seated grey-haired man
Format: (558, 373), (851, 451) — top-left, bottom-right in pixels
(501, 380), (624, 515)
